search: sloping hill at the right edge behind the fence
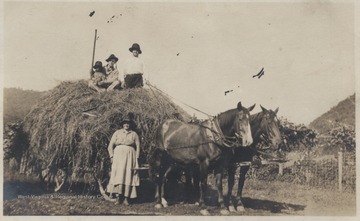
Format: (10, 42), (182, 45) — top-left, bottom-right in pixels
(309, 94), (355, 134)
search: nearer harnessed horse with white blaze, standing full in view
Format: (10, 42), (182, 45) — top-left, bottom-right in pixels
(149, 102), (255, 214)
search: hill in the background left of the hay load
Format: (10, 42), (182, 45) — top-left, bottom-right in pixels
(3, 88), (45, 125)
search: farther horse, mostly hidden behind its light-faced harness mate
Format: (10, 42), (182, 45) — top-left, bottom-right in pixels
(227, 105), (283, 212)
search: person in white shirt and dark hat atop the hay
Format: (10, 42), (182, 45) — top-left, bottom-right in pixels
(123, 43), (145, 88)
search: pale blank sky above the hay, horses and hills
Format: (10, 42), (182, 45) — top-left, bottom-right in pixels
(2, 1), (358, 125)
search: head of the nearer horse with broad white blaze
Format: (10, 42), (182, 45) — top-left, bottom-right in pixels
(218, 102), (255, 147)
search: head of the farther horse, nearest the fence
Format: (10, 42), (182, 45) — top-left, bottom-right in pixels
(250, 105), (282, 161)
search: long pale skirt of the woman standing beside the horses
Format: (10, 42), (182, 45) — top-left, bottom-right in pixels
(107, 145), (140, 198)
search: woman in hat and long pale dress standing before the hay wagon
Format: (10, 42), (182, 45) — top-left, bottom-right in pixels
(107, 118), (140, 205)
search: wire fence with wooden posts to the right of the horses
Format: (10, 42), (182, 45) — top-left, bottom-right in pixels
(248, 152), (356, 192)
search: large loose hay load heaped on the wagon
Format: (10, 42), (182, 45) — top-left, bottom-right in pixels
(23, 81), (190, 191)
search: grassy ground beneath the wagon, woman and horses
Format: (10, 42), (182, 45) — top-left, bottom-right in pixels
(3, 174), (356, 216)
